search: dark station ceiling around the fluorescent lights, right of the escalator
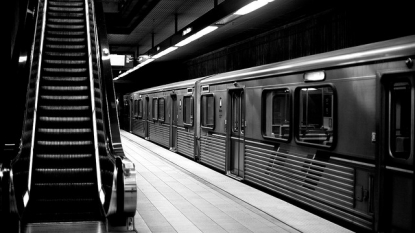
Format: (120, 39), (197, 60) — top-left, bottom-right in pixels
(102, 0), (339, 80)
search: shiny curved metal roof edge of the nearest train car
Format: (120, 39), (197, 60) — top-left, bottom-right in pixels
(200, 35), (415, 84)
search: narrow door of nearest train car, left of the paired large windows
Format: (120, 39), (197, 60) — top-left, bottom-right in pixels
(227, 89), (245, 178)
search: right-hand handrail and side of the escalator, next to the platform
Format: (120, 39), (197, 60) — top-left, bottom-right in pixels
(90, 0), (137, 217)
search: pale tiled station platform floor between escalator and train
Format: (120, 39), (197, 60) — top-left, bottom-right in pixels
(121, 131), (351, 233)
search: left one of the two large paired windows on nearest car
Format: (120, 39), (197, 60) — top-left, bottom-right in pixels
(262, 88), (291, 141)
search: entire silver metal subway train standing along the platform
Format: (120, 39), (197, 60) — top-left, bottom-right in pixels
(120, 36), (415, 232)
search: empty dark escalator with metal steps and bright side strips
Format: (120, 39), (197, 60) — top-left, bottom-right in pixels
(2, 0), (136, 231)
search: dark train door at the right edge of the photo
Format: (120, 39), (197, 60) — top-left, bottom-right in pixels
(378, 72), (415, 232)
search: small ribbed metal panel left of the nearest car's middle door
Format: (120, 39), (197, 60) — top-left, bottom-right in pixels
(200, 135), (226, 171)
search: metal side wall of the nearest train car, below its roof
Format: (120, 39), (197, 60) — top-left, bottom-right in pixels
(200, 52), (413, 229)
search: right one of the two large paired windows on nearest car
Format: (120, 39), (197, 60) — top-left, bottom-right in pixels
(296, 86), (335, 147)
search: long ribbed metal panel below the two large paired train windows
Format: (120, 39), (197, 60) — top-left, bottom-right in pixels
(245, 141), (372, 227)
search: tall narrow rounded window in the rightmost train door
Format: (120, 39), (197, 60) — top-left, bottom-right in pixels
(389, 81), (414, 159)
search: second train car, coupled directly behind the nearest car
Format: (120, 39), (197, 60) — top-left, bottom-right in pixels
(130, 79), (200, 159)
